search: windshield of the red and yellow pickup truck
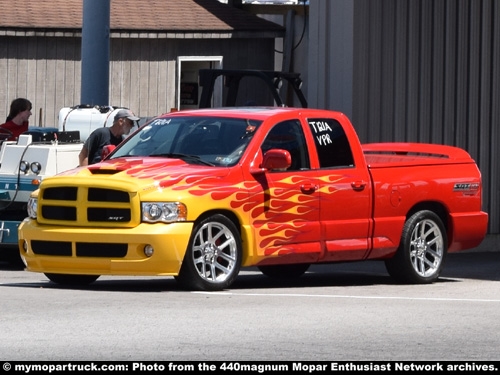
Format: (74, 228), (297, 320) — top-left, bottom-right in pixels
(110, 117), (261, 166)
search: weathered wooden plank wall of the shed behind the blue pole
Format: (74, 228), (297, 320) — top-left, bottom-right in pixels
(0, 36), (274, 127)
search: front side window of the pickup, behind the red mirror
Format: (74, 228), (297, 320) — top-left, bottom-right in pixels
(262, 120), (310, 171)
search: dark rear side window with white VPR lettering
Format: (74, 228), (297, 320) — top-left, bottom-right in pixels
(308, 119), (354, 168)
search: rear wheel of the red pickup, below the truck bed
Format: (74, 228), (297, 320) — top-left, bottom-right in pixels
(385, 210), (448, 284)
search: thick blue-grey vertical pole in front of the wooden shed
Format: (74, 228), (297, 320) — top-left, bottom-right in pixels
(80, 0), (110, 105)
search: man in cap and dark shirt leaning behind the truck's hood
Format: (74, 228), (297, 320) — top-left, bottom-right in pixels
(78, 109), (139, 166)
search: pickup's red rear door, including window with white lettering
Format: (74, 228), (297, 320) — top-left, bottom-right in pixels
(308, 118), (371, 261)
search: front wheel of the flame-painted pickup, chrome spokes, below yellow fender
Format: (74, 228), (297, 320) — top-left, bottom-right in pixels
(176, 214), (242, 291)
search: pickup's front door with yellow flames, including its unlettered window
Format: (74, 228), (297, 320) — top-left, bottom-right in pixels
(255, 120), (321, 264)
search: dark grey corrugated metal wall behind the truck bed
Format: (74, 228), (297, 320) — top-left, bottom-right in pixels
(309, 0), (500, 234)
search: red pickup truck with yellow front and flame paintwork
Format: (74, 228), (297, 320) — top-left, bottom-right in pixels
(19, 107), (488, 291)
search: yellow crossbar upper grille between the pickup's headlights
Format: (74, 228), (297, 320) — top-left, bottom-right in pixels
(38, 186), (136, 226)
